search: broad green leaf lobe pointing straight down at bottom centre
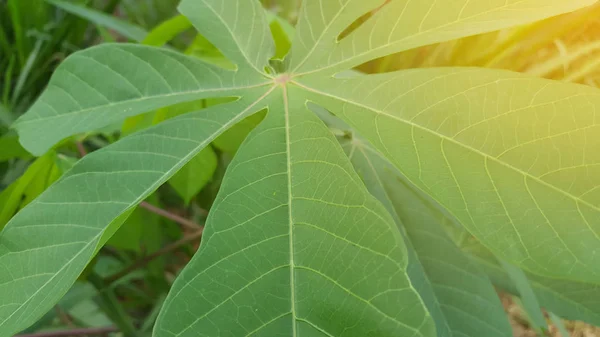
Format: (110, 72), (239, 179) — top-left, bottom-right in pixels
(155, 89), (435, 336)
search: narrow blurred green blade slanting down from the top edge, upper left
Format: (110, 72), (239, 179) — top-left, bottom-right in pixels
(46, 0), (148, 42)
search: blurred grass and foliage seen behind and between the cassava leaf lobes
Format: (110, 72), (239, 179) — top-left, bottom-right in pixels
(0, 0), (600, 337)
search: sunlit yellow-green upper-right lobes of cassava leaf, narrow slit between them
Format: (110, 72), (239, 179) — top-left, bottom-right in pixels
(290, 0), (596, 76)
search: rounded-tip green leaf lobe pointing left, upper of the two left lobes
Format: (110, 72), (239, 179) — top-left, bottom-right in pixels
(15, 44), (270, 155)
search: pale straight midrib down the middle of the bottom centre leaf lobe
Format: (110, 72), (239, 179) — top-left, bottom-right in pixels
(282, 85), (296, 337)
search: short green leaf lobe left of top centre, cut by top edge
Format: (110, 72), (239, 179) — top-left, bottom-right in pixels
(179, 0), (275, 75)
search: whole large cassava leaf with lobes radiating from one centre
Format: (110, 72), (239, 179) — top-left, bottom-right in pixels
(0, 0), (600, 337)
